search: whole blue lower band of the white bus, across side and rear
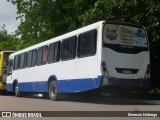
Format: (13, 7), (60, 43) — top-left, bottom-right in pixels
(7, 76), (151, 93)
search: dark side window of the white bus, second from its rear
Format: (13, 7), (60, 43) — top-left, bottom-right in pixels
(61, 36), (76, 60)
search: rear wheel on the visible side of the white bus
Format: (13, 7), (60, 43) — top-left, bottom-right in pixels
(49, 81), (59, 101)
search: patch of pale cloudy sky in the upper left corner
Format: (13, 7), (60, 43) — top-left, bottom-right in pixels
(0, 0), (20, 34)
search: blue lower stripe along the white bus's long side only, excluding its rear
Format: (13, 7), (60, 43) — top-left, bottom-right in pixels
(7, 76), (102, 93)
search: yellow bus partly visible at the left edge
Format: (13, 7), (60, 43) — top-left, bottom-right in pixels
(0, 51), (13, 93)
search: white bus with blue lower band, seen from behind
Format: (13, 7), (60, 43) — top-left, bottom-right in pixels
(7, 21), (150, 100)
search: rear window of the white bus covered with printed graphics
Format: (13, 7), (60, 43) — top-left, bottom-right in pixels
(103, 23), (148, 48)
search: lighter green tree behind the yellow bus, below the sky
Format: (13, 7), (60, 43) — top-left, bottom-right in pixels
(0, 25), (20, 51)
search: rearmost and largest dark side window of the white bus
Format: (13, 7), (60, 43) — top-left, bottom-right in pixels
(78, 30), (97, 57)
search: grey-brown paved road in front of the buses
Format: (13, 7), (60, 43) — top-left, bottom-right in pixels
(0, 95), (160, 120)
